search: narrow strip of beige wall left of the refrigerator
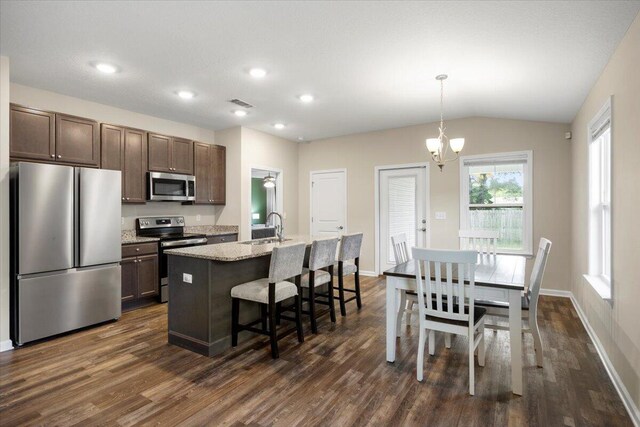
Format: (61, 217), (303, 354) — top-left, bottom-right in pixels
(0, 56), (11, 351)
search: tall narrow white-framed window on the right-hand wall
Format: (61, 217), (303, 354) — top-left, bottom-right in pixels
(586, 99), (611, 299)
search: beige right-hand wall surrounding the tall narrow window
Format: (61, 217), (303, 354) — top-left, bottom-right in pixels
(571, 15), (640, 412)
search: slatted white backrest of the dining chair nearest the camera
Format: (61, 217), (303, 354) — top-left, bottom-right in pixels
(411, 248), (478, 327)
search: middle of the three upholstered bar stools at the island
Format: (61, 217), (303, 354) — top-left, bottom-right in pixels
(299, 237), (339, 334)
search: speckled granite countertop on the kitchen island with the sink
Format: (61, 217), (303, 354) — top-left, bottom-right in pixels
(165, 235), (338, 261)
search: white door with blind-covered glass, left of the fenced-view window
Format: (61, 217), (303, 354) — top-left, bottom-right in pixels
(378, 166), (428, 272)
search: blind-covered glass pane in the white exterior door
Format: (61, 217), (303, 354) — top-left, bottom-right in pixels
(388, 176), (418, 264)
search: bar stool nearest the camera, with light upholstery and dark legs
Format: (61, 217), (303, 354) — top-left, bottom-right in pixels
(231, 243), (306, 359)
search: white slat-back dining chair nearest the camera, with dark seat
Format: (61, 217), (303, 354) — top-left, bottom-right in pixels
(411, 248), (487, 395)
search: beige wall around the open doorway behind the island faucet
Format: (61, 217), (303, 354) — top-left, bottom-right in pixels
(240, 127), (299, 239)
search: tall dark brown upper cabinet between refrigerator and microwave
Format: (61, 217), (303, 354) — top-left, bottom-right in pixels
(100, 124), (147, 203)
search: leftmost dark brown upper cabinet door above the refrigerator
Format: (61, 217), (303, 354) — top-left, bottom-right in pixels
(9, 104), (56, 161)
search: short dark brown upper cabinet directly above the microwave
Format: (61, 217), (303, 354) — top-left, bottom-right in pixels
(148, 133), (193, 175)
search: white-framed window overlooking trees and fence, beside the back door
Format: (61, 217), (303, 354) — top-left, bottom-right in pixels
(460, 151), (533, 255)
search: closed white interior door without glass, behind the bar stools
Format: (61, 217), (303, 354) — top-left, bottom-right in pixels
(311, 170), (347, 236)
